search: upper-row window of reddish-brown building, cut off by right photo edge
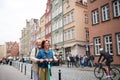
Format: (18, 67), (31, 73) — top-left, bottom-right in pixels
(113, 0), (120, 17)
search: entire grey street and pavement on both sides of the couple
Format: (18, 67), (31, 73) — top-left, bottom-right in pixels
(0, 61), (119, 80)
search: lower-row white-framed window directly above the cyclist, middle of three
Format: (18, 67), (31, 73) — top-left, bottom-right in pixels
(104, 35), (113, 55)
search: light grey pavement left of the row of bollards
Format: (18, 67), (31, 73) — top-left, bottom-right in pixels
(0, 65), (32, 80)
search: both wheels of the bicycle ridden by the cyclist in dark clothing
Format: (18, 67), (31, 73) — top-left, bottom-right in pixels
(94, 63), (120, 80)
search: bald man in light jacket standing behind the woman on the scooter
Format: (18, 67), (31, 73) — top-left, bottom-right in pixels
(30, 40), (41, 80)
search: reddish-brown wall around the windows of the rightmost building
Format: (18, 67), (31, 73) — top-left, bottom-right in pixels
(88, 0), (120, 64)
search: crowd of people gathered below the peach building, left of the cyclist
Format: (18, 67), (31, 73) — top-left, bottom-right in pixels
(67, 54), (95, 68)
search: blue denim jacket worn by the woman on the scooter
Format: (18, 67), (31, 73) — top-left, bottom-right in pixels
(36, 49), (54, 68)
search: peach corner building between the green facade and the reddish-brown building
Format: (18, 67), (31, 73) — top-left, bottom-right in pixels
(63, 0), (87, 56)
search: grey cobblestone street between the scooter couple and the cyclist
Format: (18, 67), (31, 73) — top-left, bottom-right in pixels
(52, 67), (96, 80)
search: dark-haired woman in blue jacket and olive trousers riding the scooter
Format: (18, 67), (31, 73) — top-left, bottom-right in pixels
(37, 40), (57, 80)
